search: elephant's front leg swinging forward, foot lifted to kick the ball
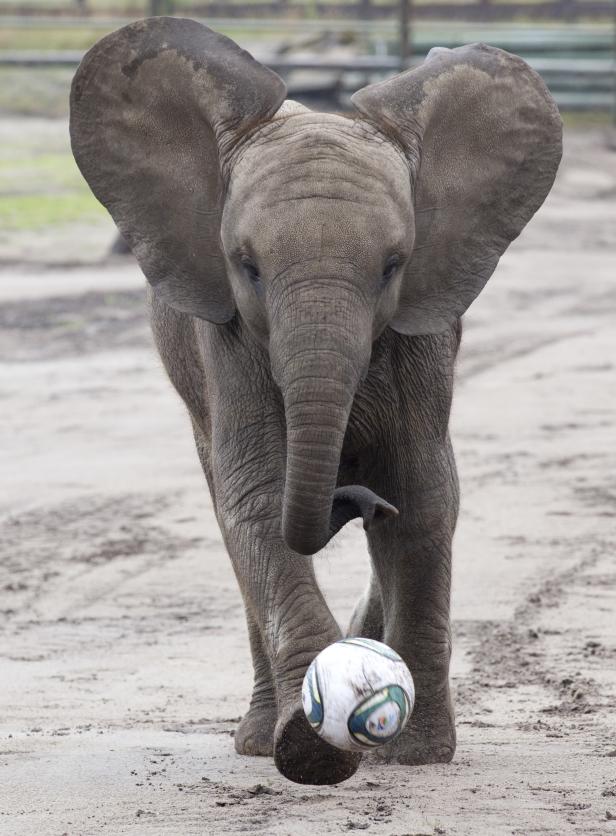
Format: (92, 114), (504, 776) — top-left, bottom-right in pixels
(212, 388), (360, 784)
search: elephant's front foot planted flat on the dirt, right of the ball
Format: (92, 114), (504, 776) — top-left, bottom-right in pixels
(374, 711), (456, 766)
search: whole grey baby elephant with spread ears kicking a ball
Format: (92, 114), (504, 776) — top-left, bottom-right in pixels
(71, 18), (561, 784)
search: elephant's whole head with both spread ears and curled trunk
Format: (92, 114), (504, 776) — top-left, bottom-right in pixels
(71, 18), (561, 554)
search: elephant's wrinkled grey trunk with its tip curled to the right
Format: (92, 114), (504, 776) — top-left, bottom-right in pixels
(270, 278), (397, 554)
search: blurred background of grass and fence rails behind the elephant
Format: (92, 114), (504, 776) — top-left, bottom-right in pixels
(0, 0), (616, 264)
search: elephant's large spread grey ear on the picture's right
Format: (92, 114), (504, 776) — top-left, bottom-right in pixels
(352, 44), (562, 334)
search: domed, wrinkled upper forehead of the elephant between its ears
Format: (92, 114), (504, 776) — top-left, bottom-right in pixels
(233, 112), (410, 208)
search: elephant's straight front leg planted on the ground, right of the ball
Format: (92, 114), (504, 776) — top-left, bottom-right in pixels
(369, 439), (458, 764)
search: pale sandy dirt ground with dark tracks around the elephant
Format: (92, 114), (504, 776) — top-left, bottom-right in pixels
(0, 127), (616, 836)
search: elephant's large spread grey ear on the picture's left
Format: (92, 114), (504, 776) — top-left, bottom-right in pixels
(71, 17), (285, 323)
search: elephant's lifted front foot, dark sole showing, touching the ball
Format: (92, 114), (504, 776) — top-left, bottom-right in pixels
(274, 703), (361, 784)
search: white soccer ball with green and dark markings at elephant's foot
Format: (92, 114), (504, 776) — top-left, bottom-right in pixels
(302, 638), (415, 752)
